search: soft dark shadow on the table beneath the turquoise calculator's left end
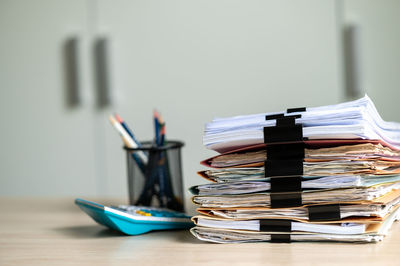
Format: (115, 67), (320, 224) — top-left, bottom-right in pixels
(53, 225), (127, 239)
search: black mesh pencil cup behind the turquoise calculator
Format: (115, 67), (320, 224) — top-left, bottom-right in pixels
(124, 141), (184, 211)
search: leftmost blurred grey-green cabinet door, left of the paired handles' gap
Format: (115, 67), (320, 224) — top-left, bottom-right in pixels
(0, 0), (98, 196)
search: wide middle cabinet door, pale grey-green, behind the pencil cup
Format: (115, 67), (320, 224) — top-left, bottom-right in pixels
(97, 0), (341, 203)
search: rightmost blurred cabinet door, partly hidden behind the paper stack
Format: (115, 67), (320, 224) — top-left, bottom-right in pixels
(343, 0), (400, 121)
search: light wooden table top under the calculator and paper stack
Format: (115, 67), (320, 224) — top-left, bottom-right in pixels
(0, 198), (400, 266)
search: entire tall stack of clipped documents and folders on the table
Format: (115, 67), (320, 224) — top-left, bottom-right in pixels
(190, 96), (400, 243)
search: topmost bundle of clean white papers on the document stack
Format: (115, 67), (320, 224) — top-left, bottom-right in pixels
(203, 96), (400, 152)
